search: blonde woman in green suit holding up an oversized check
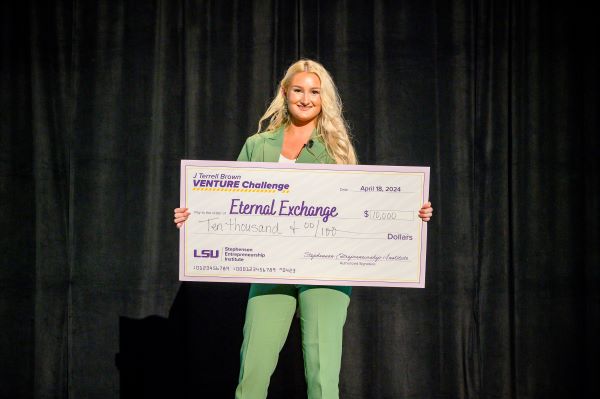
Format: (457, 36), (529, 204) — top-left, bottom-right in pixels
(174, 60), (433, 399)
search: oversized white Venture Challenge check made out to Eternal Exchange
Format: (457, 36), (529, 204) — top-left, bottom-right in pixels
(179, 160), (429, 288)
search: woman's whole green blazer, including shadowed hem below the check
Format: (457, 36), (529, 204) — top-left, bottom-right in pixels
(237, 126), (352, 298)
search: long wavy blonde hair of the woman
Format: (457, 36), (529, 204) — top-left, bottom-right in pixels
(257, 59), (357, 165)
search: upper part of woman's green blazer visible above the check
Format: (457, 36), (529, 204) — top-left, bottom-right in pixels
(237, 126), (335, 163)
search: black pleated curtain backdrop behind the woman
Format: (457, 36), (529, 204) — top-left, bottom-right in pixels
(0, 0), (600, 399)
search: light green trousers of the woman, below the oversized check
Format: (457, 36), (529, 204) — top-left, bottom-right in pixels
(235, 284), (351, 399)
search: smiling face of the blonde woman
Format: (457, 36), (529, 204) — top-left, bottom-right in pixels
(283, 72), (321, 125)
